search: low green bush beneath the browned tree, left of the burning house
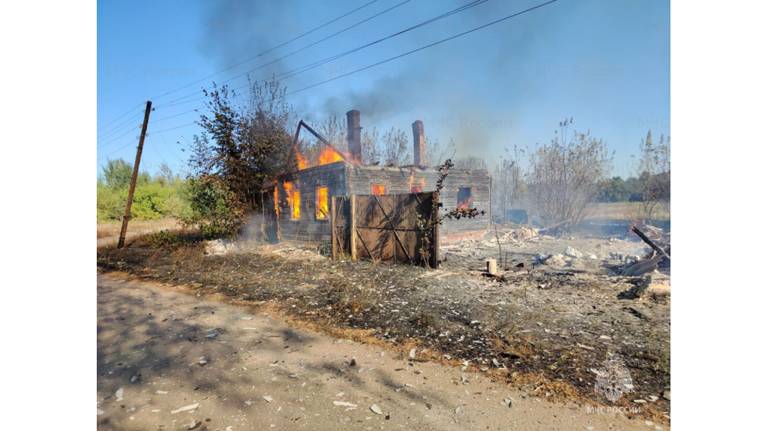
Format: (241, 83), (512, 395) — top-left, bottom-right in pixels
(182, 175), (245, 238)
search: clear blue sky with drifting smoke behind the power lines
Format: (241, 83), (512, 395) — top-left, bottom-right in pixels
(97, 0), (670, 176)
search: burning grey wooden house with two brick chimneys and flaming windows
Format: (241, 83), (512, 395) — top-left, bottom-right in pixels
(263, 110), (491, 248)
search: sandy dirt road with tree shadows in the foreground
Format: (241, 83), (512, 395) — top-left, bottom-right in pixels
(97, 274), (666, 431)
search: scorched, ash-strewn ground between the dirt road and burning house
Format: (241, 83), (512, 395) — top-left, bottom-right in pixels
(98, 227), (670, 418)
